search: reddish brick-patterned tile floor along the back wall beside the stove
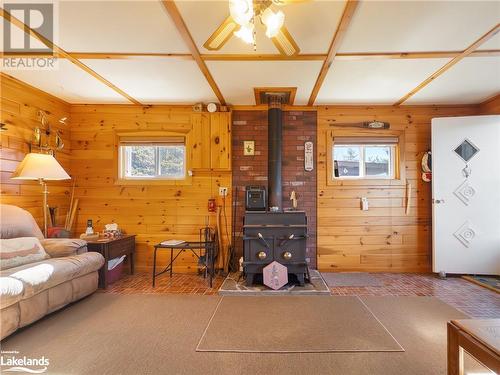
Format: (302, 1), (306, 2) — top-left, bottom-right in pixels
(105, 273), (500, 318)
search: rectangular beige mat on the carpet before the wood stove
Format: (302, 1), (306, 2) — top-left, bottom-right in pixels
(196, 296), (404, 353)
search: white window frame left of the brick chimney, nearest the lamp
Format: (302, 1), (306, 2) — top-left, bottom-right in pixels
(118, 139), (187, 181)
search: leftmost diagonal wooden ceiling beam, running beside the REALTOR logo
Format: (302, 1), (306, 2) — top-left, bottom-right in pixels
(0, 7), (142, 105)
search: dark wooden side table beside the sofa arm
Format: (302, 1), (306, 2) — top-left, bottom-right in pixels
(87, 234), (135, 289)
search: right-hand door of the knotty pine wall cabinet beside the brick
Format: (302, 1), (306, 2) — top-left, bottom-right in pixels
(210, 112), (231, 170)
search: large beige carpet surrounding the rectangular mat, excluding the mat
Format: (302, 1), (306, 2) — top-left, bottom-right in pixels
(2, 293), (482, 375)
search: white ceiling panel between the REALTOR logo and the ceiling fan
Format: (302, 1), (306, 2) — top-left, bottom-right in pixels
(59, 0), (189, 53)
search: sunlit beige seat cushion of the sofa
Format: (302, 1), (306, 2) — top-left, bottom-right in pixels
(1, 252), (104, 299)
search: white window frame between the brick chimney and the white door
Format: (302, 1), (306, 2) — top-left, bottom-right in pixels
(331, 143), (396, 180)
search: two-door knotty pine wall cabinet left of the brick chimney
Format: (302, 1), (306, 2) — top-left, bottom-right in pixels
(192, 112), (231, 171)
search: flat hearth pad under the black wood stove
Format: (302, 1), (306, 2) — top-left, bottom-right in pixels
(219, 270), (330, 296)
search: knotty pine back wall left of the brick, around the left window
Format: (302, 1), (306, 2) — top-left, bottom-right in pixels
(71, 105), (231, 272)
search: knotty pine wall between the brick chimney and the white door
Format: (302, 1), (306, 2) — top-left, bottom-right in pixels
(317, 106), (478, 272)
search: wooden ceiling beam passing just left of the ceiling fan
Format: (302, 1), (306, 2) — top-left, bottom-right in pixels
(162, 0), (226, 105)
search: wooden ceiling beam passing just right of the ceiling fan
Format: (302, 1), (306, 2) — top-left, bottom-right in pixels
(308, 0), (358, 105)
